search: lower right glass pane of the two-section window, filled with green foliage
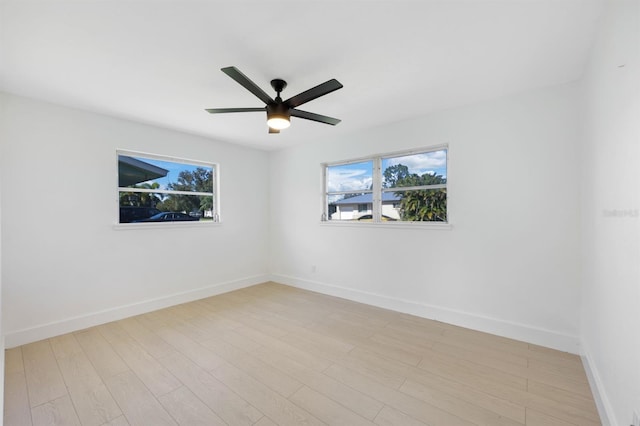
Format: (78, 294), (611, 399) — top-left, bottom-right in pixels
(382, 188), (447, 222)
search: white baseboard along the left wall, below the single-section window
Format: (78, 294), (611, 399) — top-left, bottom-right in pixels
(4, 274), (269, 349)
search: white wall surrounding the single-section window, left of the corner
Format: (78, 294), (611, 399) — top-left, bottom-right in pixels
(0, 94), (269, 347)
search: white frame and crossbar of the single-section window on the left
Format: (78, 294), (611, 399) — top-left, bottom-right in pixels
(114, 149), (222, 229)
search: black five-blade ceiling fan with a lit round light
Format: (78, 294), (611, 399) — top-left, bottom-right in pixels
(206, 67), (342, 133)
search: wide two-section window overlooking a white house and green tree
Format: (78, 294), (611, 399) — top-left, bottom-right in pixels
(323, 146), (448, 223)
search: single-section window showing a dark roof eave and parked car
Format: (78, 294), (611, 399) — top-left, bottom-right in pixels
(117, 151), (220, 223)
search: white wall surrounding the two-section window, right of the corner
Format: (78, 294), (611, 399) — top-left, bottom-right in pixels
(270, 85), (579, 353)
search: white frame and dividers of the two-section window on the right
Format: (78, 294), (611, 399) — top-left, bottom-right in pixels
(320, 144), (451, 229)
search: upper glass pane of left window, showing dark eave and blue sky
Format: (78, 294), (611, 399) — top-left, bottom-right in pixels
(118, 155), (214, 192)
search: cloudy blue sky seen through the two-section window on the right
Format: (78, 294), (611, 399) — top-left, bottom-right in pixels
(327, 150), (447, 192)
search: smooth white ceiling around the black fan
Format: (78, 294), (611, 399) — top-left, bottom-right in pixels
(0, 0), (601, 149)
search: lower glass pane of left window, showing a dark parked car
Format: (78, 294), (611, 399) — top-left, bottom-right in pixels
(120, 195), (215, 223)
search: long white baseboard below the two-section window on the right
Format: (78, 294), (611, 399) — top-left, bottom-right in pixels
(271, 274), (580, 354)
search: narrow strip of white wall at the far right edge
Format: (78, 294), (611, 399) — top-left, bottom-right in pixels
(581, 0), (640, 425)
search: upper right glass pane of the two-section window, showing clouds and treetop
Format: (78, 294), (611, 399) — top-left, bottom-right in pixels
(382, 149), (447, 188)
